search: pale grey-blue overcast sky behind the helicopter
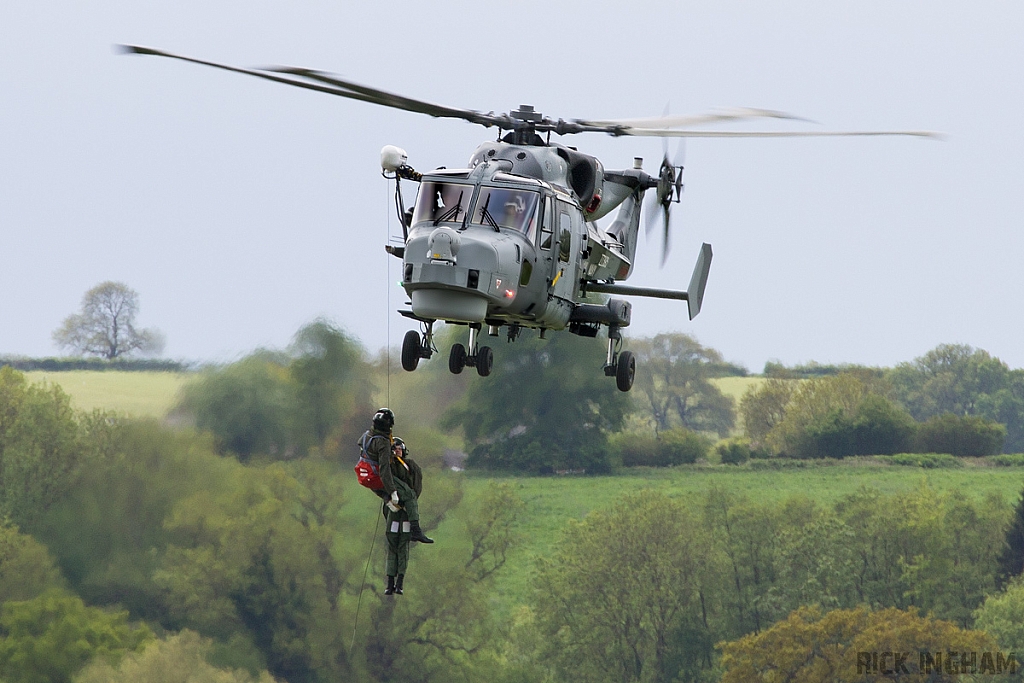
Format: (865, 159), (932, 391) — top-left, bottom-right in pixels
(0, 0), (1024, 372)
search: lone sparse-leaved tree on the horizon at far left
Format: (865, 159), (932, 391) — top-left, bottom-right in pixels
(53, 282), (164, 360)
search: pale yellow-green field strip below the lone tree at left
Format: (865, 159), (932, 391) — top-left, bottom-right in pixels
(25, 370), (194, 418)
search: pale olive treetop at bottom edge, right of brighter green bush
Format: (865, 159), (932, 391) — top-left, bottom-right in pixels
(75, 630), (274, 683)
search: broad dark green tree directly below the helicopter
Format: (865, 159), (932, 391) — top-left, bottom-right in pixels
(441, 335), (629, 473)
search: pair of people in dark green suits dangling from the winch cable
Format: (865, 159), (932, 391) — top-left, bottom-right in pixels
(355, 408), (434, 595)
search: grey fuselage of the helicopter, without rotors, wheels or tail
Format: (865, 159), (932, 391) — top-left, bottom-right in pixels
(402, 142), (639, 330)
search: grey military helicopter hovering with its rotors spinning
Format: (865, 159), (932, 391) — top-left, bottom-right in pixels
(118, 45), (937, 391)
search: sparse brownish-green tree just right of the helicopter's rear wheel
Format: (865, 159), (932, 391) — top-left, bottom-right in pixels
(632, 333), (735, 436)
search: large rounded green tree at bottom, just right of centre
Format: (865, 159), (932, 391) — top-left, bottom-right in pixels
(535, 492), (711, 682)
